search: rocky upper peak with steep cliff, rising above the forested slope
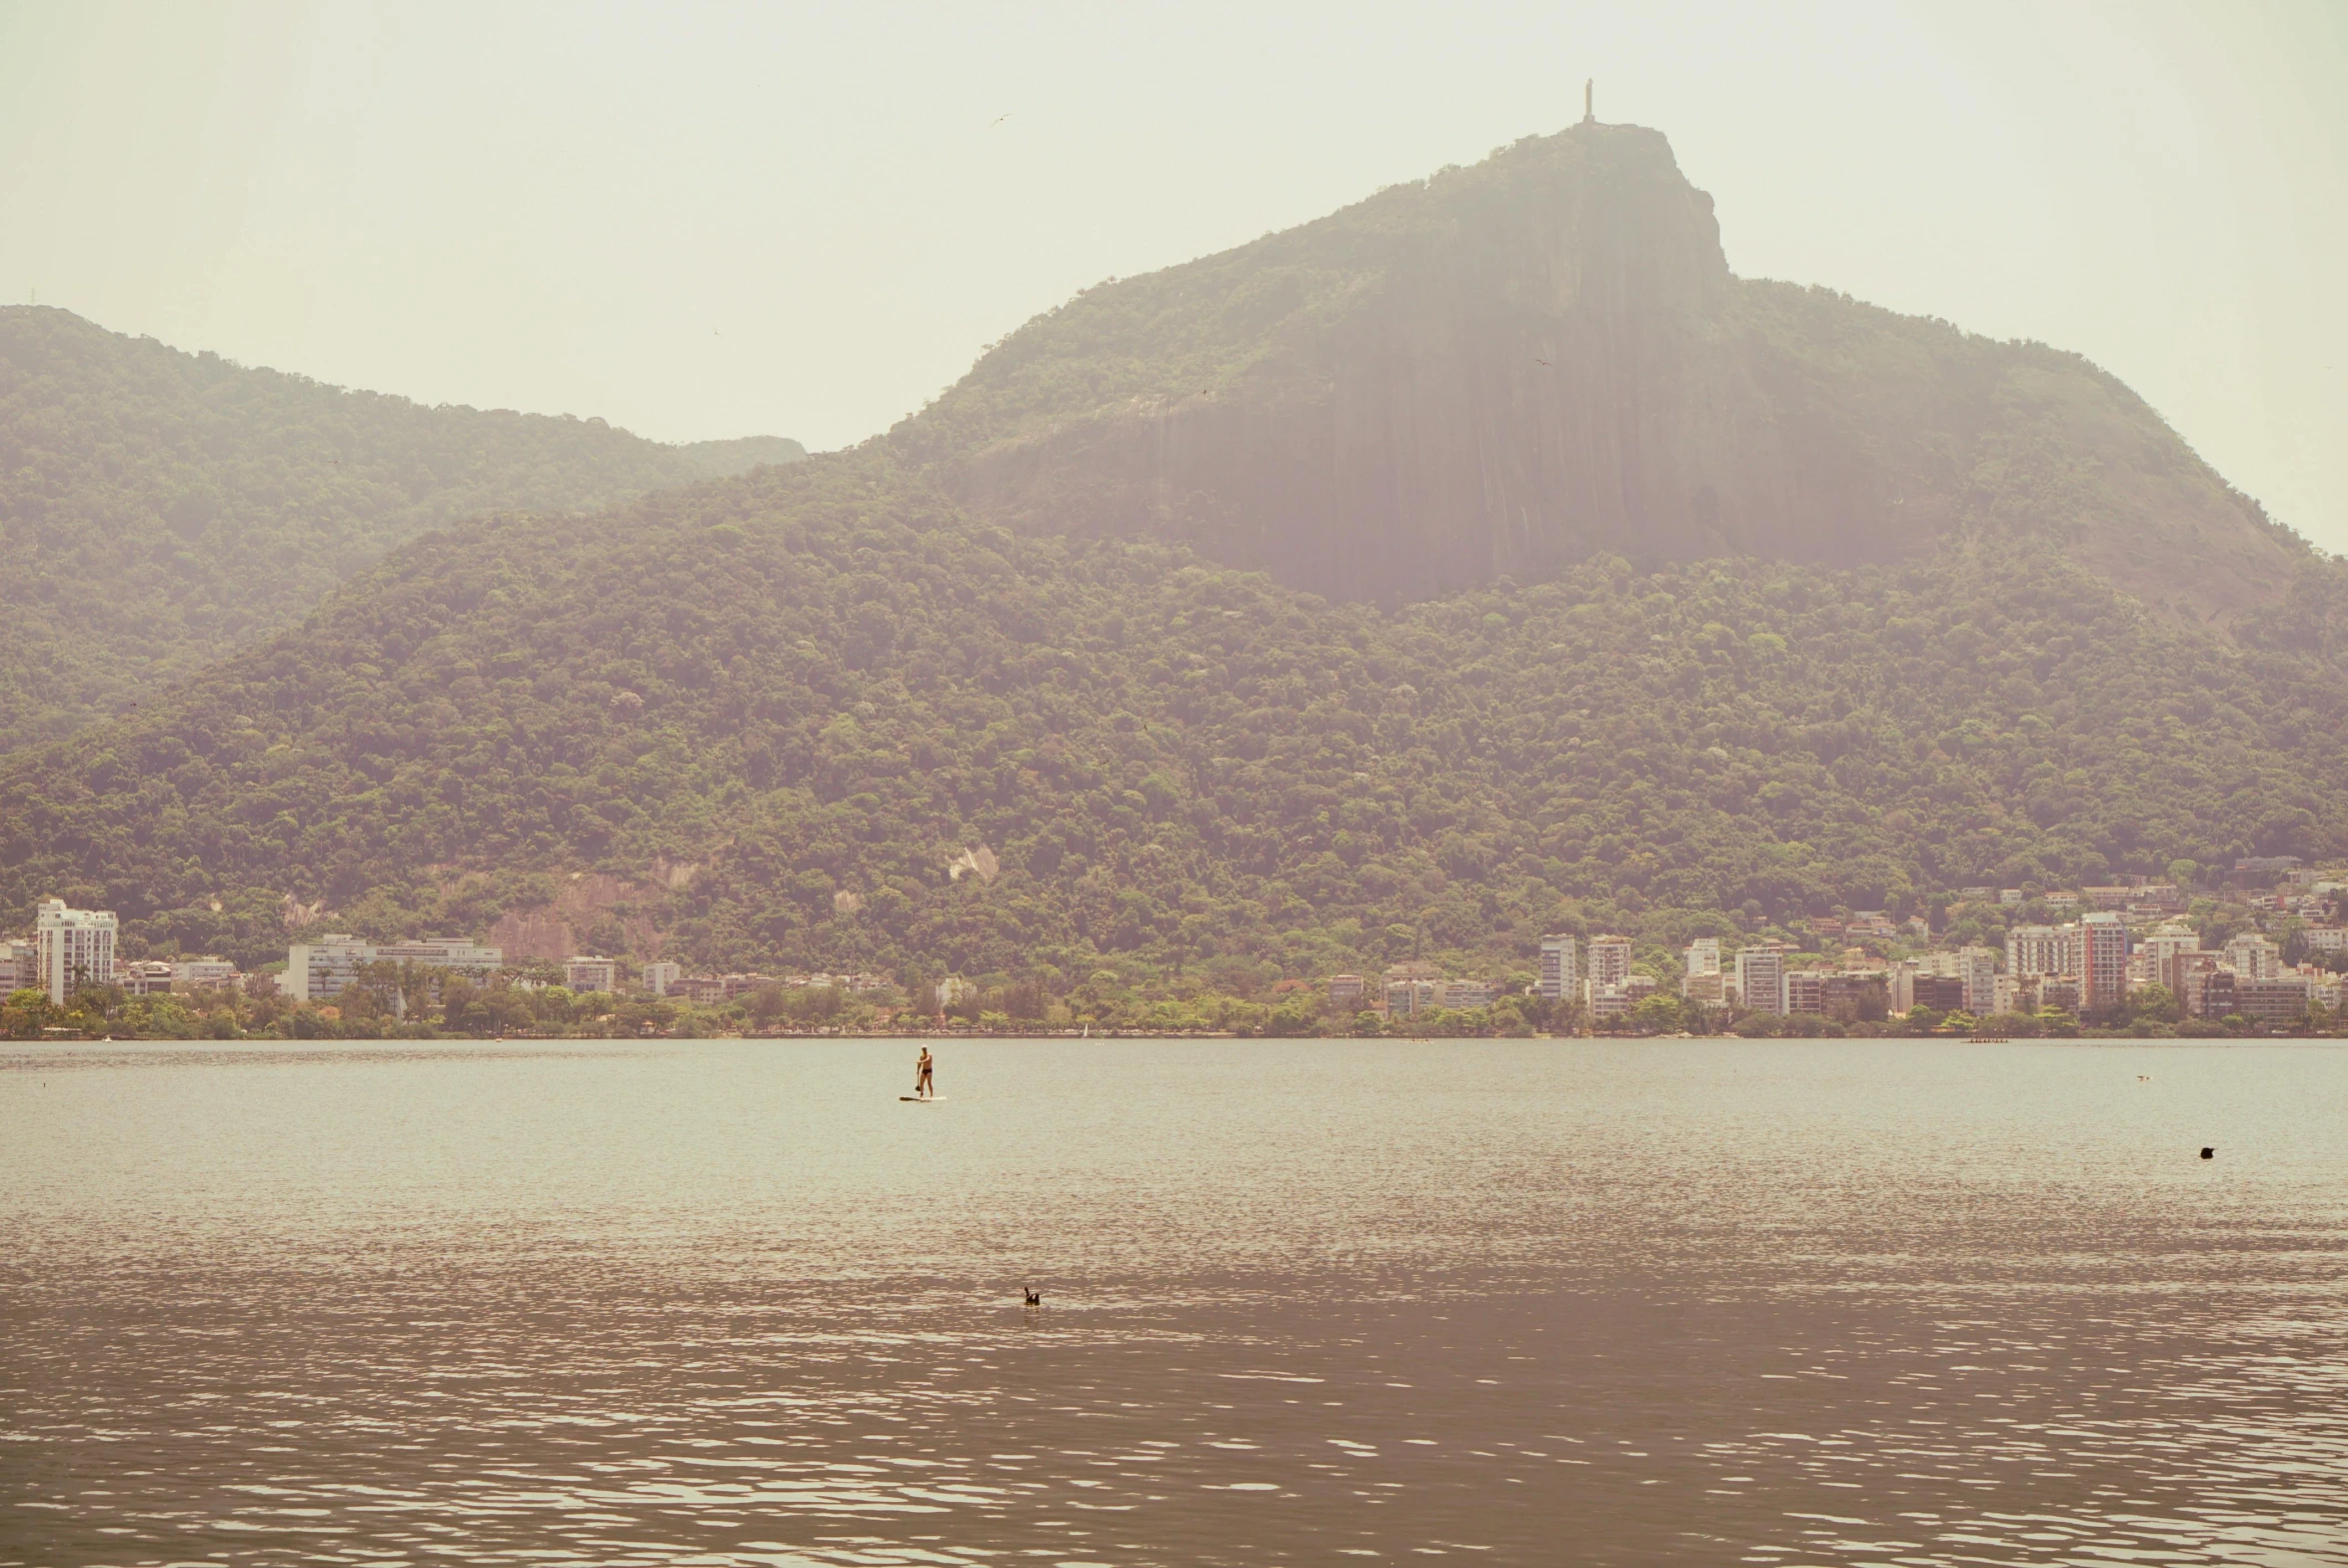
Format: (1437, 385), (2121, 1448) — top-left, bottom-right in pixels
(895, 124), (2303, 620)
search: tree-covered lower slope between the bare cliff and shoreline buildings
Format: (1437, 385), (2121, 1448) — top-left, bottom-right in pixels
(0, 451), (2348, 976)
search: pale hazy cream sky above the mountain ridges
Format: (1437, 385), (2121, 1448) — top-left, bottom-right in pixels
(0, 0), (2348, 552)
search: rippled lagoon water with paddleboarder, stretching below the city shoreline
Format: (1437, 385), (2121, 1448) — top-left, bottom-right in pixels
(0, 1040), (2348, 1568)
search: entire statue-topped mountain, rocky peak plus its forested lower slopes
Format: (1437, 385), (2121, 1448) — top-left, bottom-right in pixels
(0, 127), (2348, 978)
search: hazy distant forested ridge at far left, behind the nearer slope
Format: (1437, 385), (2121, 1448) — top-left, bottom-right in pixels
(0, 305), (806, 752)
